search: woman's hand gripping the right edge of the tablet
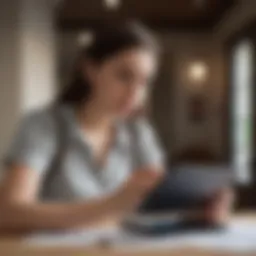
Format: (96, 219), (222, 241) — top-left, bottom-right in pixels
(203, 188), (235, 224)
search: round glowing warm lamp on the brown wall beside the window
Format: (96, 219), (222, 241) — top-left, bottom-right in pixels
(188, 62), (208, 83)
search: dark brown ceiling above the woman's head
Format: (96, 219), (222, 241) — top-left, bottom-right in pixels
(57, 0), (235, 30)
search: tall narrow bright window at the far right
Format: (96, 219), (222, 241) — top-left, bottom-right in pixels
(231, 40), (254, 183)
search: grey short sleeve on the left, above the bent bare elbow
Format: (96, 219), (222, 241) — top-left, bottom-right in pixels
(5, 111), (56, 173)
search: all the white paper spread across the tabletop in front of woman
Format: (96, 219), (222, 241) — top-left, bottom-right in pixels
(24, 221), (256, 253)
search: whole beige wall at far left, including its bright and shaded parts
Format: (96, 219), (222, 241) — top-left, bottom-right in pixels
(0, 0), (56, 172)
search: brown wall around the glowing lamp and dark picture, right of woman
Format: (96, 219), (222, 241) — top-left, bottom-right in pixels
(156, 33), (225, 161)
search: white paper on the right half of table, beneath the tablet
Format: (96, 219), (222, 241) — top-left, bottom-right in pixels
(115, 221), (256, 253)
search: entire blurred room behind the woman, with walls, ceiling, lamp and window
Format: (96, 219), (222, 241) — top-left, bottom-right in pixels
(0, 0), (256, 208)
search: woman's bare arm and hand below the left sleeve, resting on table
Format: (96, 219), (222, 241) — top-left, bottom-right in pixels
(0, 166), (161, 231)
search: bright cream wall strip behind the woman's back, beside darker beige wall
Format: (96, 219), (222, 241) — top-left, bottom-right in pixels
(19, 0), (56, 113)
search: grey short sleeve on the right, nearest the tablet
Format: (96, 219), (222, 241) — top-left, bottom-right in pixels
(132, 119), (165, 170)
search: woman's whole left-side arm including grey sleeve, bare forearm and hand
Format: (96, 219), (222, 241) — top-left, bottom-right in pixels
(0, 112), (164, 230)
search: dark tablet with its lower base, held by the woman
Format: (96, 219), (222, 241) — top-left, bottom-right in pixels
(123, 165), (234, 236)
